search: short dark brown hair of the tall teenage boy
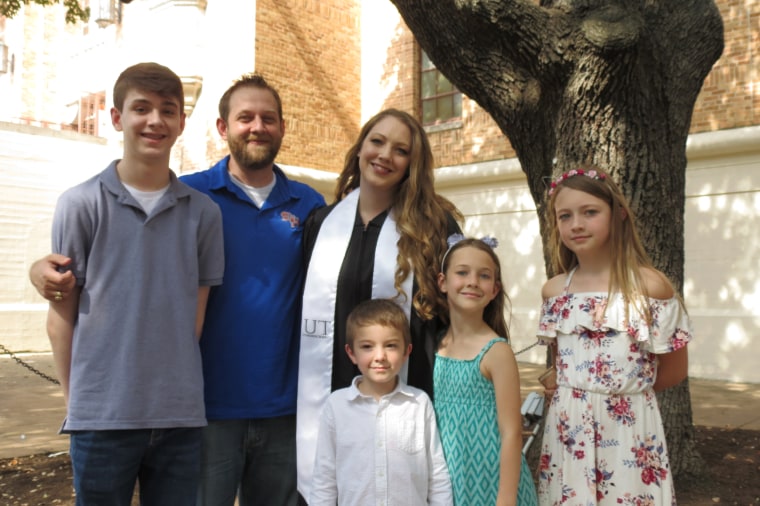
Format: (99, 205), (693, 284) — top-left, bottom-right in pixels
(113, 62), (185, 112)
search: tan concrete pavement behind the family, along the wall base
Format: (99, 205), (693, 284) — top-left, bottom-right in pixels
(0, 354), (760, 459)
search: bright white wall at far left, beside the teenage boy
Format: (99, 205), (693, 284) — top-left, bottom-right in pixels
(0, 122), (119, 351)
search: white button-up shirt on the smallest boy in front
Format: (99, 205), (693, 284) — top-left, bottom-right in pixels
(309, 376), (453, 506)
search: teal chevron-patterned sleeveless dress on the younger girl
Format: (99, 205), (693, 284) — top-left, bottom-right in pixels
(433, 337), (538, 506)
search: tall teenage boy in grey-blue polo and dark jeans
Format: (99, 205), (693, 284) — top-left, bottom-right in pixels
(47, 63), (224, 506)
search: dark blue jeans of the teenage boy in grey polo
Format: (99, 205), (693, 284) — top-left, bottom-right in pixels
(71, 427), (201, 506)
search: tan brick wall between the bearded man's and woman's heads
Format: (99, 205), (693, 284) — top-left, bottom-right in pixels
(256, 0), (361, 172)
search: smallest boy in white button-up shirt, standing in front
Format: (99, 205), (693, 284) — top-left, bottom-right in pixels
(309, 299), (453, 506)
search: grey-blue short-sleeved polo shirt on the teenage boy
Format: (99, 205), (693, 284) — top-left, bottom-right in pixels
(53, 161), (224, 431)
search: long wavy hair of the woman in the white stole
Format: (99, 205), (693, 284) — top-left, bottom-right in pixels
(335, 109), (463, 320)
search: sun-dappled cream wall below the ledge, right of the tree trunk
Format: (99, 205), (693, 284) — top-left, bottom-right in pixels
(684, 157), (760, 383)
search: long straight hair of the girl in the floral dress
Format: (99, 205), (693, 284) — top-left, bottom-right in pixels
(546, 165), (654, 323)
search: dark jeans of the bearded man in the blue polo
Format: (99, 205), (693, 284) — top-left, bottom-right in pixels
(197, 416), (297, 506)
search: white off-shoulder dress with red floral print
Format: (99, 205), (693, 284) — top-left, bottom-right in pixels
(538, 271), (691, 506)
